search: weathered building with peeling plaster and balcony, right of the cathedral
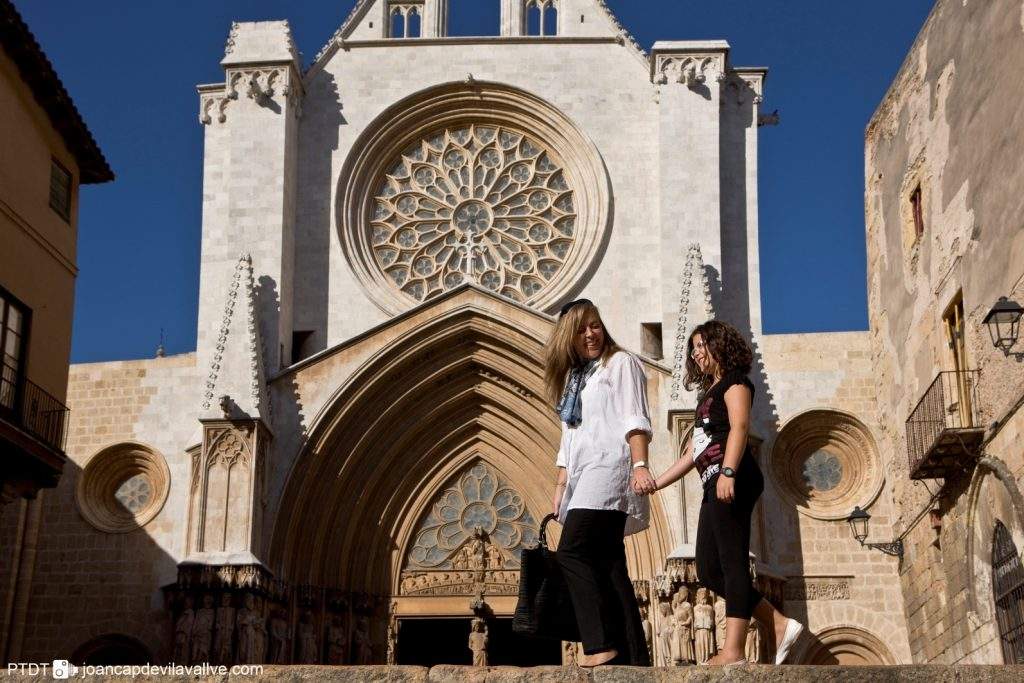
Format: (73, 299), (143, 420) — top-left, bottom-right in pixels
(865, 0), (1024, 664)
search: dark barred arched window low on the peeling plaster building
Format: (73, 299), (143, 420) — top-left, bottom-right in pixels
(992, 521), (1024, 664)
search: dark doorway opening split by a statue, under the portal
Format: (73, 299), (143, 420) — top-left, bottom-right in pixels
(395, 618), (562, 667)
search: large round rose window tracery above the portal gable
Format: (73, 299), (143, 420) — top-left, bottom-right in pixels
(370, 125), (577, 301)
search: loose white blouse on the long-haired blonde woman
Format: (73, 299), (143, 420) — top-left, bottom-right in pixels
(556, 351), (652, 536)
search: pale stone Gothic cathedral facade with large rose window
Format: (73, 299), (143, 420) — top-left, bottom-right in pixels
(0, 0), (910, 665)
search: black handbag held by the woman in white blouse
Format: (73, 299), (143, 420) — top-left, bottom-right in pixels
(512, 514), (580, 642)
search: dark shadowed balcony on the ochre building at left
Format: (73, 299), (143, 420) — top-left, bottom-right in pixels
(0, 378), (70, 502)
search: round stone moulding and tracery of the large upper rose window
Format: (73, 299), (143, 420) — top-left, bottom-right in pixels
(335, 81), (612, 315)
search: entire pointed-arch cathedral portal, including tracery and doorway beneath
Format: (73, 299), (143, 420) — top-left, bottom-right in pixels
(270, 289), (669, 664)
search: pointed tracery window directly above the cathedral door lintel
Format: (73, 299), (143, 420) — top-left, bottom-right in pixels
(407, 463), (537, 569)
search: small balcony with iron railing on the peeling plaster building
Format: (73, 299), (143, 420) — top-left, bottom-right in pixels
(906, 370), (985, 479)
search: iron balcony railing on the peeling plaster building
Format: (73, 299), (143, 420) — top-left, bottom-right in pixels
(906, 370), (981, 476)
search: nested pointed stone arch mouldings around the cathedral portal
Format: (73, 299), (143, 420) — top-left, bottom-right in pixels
(269, 289), (670, 606)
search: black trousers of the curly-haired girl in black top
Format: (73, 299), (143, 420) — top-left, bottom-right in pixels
(696, 454), (765, 620)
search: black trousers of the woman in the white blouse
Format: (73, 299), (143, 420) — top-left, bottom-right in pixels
(557, 510), (650, 667)
